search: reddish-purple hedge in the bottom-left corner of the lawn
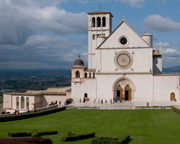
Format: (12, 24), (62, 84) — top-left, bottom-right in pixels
(0, 138), (52, 144)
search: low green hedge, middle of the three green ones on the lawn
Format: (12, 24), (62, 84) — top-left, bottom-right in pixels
(61, 132), (95, 142)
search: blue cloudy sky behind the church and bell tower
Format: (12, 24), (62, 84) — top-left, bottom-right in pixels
(0, 0), (180, 69)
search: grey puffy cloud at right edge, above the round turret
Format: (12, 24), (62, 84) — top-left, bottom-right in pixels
(144, 15), (180, 32)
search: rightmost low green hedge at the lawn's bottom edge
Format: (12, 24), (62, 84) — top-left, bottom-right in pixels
(91, 135), (130, 144)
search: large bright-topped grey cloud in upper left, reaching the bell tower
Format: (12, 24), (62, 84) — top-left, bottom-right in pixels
(0, 0), (87, 45)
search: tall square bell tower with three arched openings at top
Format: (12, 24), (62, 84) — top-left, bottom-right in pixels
(88, 11), (113, 69)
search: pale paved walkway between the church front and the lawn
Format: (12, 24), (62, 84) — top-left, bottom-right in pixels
(68, 101), (178, 109)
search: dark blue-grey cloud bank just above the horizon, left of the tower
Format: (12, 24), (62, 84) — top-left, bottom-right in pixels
(0, 35), (87, 69)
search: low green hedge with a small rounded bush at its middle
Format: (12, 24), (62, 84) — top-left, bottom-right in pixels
(8, 130), (58, 137)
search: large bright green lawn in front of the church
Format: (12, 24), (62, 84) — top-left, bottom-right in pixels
(0, 110), (180, 144)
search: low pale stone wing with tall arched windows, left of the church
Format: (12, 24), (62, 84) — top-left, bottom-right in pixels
(3, 87), (71, 113)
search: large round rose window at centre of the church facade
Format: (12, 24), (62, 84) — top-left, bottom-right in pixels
(114, 51), (133, 69)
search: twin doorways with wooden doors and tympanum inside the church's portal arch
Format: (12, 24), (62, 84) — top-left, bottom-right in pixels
(113, 78), (134, 101)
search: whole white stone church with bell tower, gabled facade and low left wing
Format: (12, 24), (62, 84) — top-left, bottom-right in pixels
(3, 11), (180, 111)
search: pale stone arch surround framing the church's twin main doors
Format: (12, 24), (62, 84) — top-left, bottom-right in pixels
(112, 77), (136, 100)
